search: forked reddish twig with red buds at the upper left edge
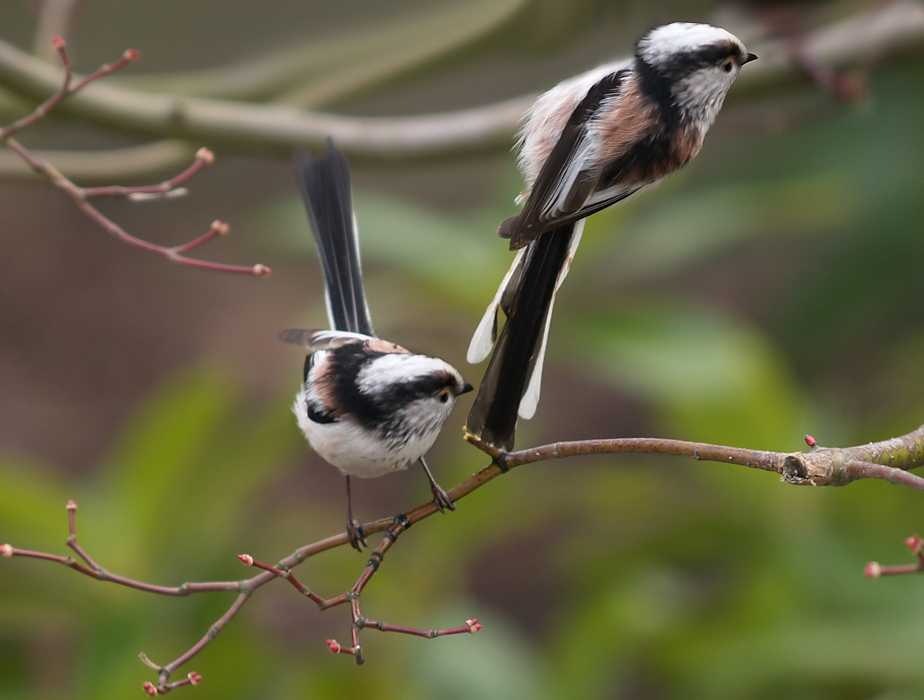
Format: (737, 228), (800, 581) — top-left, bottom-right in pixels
(0, 37), (271, 277)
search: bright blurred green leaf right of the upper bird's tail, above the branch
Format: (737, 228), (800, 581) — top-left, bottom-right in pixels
(568, 300), (802, 447)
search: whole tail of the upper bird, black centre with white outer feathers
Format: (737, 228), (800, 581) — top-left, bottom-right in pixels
(466, 219), (584, 450)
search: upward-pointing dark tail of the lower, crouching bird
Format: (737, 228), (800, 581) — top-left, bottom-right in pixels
(295, 140), (375, 335)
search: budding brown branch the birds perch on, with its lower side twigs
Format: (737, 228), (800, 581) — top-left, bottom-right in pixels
(0, 425), (924, 695)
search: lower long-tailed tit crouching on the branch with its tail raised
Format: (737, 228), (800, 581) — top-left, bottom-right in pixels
(279, 143), (472, 549)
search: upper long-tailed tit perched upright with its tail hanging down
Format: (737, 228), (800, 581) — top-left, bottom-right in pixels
(466, 23), (757, 449)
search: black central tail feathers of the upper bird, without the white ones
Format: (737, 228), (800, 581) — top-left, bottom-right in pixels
(466, 223), (575, 450)
